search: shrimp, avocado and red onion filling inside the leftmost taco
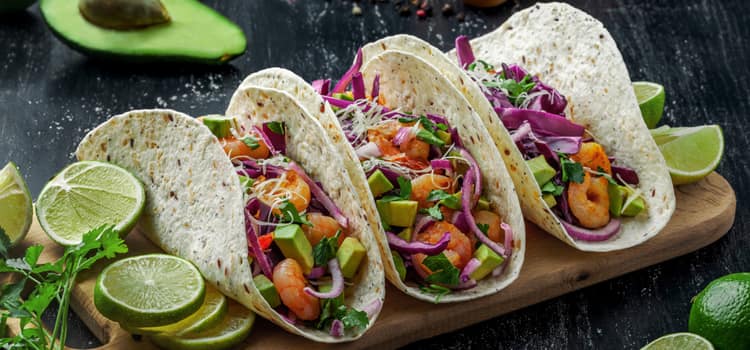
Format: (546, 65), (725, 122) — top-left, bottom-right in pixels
(202, 116), (369, 337)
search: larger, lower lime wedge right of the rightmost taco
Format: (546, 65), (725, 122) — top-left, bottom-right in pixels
(651, 125), (724, 185)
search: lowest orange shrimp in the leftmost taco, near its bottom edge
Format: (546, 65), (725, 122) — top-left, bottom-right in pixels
(272, 258), (320, 321)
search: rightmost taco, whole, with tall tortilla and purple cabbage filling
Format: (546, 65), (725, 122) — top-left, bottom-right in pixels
(362, 3), (675, 251)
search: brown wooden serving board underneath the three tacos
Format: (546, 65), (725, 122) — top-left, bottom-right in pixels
(7, 173), (736, 350)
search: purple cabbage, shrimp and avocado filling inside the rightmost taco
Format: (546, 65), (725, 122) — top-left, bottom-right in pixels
(456, 36), (647, 241)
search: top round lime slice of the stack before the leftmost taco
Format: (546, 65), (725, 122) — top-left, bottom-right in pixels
(94, 254), (206, 327)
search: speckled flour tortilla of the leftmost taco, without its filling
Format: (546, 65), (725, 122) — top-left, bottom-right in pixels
(76, 108), (385, 342)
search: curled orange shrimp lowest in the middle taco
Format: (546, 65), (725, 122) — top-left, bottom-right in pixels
(413, 221), (474, 274)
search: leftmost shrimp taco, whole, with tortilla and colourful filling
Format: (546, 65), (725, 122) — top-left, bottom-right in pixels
(76, 105), (385, 342)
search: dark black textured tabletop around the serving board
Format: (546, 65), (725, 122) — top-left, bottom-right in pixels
(0, 0), (750, 349)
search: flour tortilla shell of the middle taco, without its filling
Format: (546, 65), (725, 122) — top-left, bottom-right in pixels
(240, 60), (525, 302)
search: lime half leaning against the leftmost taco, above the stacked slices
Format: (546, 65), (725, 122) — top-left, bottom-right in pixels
(36, 161), (146, 245)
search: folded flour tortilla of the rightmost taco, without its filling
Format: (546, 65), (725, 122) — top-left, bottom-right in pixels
(362, 3), (675, 252)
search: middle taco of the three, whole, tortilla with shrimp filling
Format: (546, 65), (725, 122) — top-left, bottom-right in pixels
(242, 53), (525, 302)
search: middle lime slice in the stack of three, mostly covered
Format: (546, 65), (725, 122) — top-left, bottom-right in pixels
(126, 285), (227, 335)
